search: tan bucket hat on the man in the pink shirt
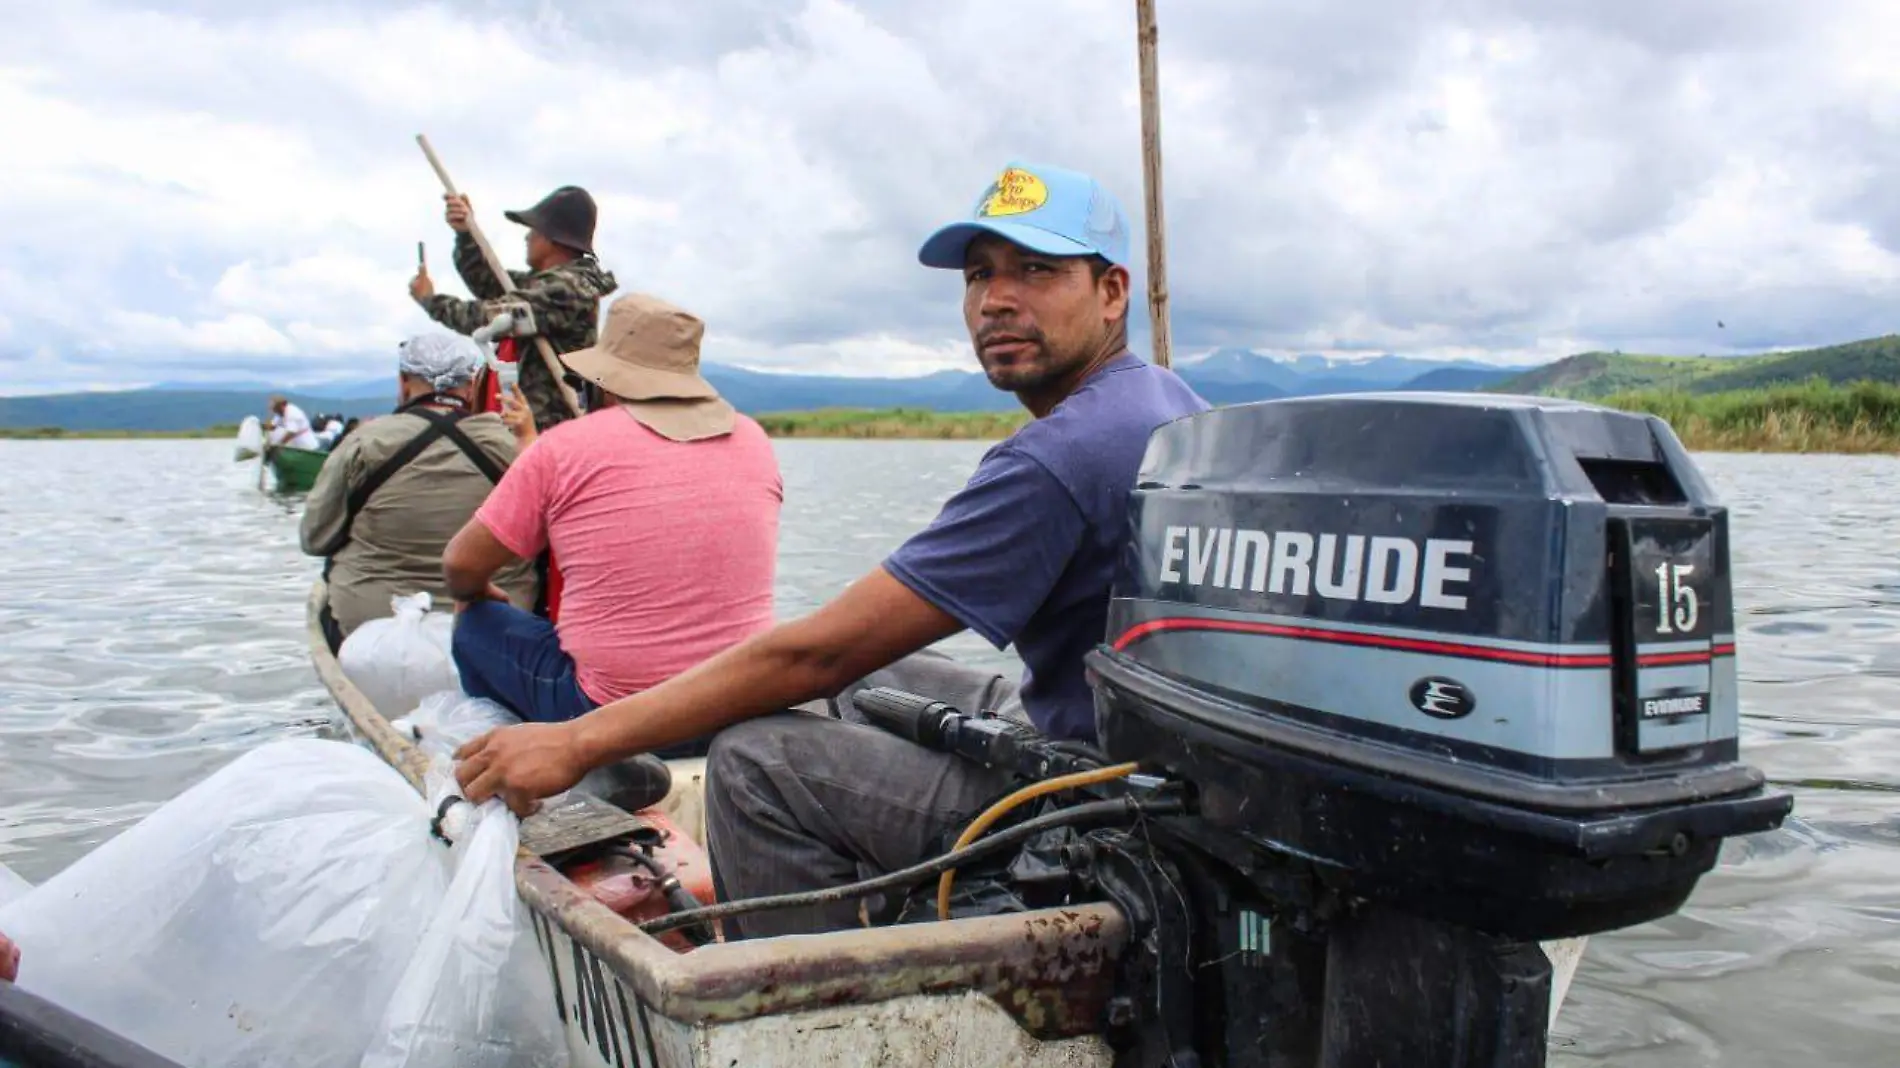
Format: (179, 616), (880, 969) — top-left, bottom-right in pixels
(561, 293), (735, 441)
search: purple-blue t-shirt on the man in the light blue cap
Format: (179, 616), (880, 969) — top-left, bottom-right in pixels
(884, 352), (1207, 741)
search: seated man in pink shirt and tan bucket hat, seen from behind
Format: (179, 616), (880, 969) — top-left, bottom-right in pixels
(443, 295), (785, 758)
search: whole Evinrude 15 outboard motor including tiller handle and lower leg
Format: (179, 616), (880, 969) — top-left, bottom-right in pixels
(857, 393), (1792, 1068)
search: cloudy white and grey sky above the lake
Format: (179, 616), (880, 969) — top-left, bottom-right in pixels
(0, 0), (1900, 393)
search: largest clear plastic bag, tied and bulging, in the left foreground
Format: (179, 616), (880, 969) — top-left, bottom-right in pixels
(0, 739), (568, 1068)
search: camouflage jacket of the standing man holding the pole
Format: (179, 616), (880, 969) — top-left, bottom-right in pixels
(422, 234), (618, 355)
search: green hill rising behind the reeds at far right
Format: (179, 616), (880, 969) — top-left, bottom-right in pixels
(1492, 334), (1900, 401)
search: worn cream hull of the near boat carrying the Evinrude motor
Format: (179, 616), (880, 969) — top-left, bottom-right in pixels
(306, 580), (1583, 1068)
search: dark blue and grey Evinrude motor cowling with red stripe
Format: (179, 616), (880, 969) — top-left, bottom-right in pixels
(1089, 385), (1792, 939)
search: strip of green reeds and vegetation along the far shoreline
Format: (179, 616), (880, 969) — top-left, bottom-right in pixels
(11, 382), (1900, 452)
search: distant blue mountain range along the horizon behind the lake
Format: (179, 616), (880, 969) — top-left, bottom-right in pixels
(0, 348), (1516, 431)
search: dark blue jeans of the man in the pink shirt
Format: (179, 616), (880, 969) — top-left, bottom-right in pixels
(450, 601), (713, 760)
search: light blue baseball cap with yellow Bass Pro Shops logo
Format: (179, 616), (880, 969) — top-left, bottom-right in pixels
(918, 163), (1129, 270)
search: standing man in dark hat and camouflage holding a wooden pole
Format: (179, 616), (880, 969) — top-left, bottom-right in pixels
(409, 156), (618, 431)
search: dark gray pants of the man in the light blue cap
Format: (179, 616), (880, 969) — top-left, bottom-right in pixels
(707, 652), (1022, 939)
